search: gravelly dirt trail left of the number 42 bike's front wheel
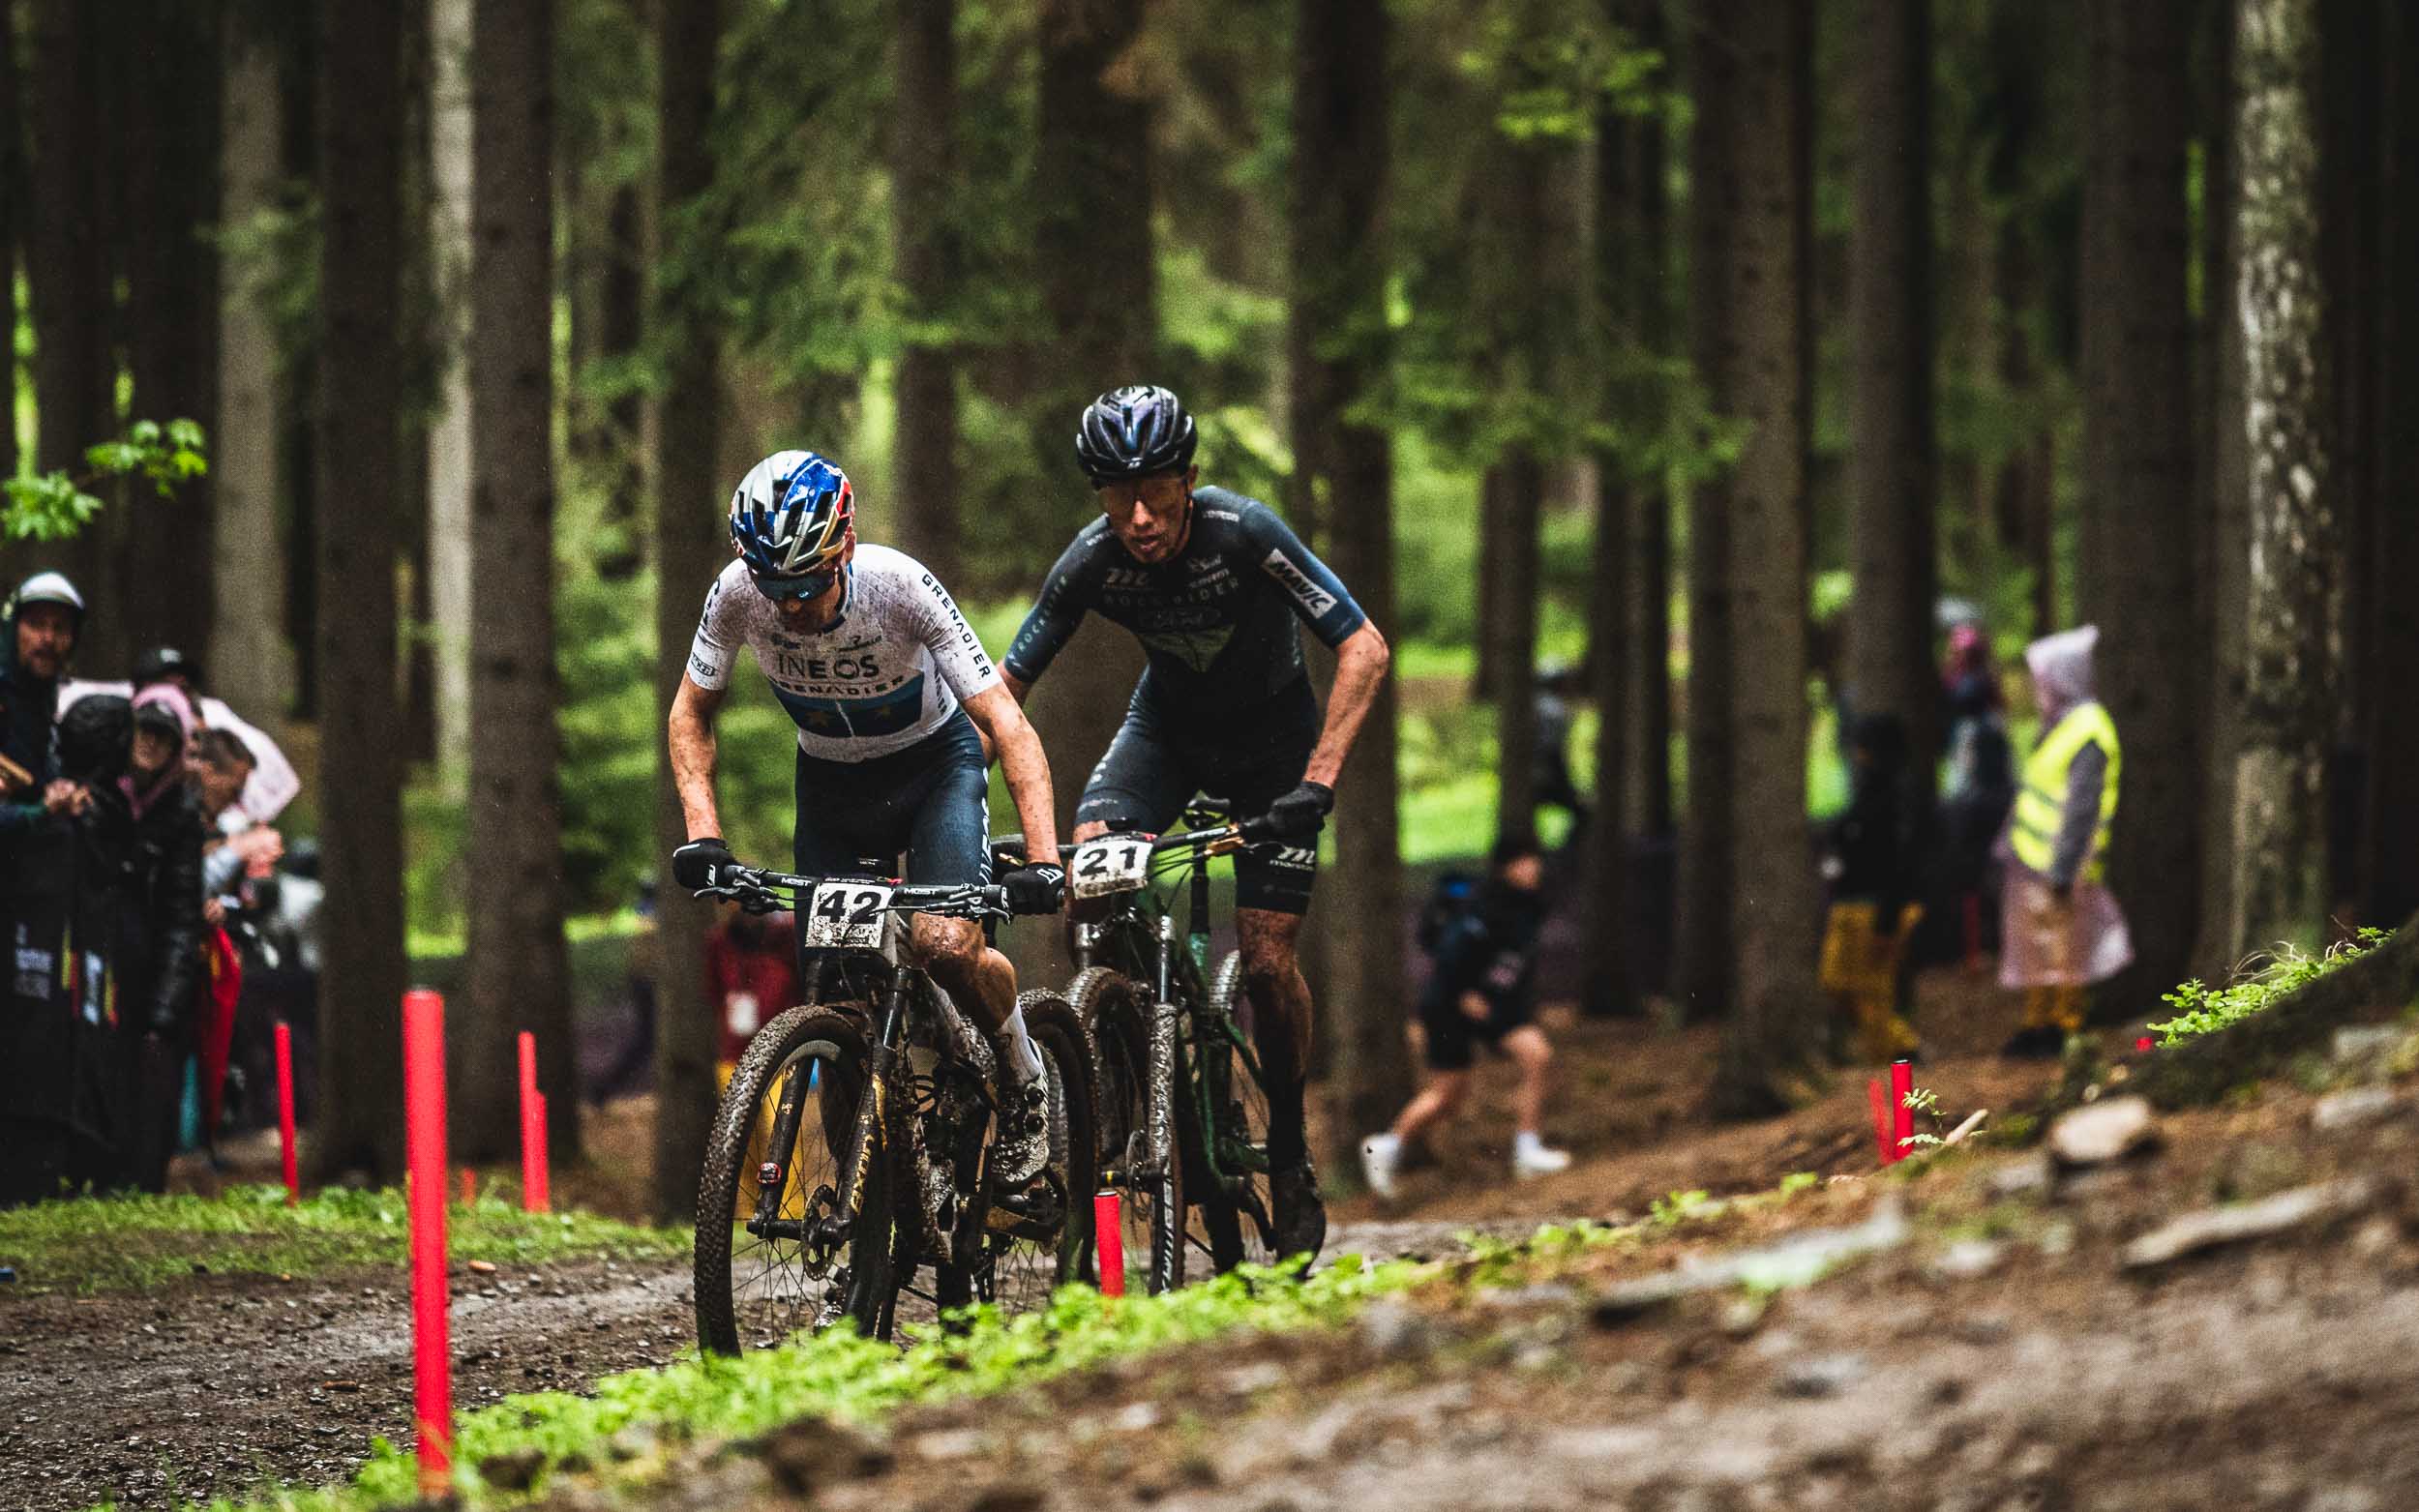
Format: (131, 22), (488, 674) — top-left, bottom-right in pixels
(0, 1262), (695, 1512)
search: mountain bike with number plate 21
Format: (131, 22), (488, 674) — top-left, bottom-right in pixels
(1067, 806), (1282, 1291)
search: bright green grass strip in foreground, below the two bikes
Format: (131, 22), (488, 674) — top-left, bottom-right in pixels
(179, 1256), (1435, 1512)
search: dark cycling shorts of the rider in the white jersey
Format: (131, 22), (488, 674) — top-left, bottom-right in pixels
(793, 709), (992, 888)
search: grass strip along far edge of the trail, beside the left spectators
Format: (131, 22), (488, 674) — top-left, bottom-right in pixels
(0, 1185), (690, 1294)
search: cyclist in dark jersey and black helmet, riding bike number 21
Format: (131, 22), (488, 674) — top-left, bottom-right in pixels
(1001, 385), (1389, 1253)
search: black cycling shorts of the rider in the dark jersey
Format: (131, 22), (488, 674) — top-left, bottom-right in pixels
(1074, 677), (1319, 914)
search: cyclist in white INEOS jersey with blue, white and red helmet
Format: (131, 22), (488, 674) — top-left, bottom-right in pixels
(671, 453), (1064, 1185)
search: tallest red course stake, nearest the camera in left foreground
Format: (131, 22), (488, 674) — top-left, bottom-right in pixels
(404, 990), (453, 1495)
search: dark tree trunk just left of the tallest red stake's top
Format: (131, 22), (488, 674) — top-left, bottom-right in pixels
(313, 5), (404, 1180)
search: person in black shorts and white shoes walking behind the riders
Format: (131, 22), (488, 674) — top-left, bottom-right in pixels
(1362, 837), (1570, 1198)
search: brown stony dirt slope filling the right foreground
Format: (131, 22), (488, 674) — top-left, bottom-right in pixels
(547, 1088), (2419, 1512)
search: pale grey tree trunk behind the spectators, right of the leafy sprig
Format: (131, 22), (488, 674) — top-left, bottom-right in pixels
(208, 15), (295, 733)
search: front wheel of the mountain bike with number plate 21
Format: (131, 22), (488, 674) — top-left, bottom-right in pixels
(1067, 965), (1185, 1294)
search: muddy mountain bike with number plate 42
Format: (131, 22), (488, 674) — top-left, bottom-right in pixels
(695, 866), (1098, 1354)
